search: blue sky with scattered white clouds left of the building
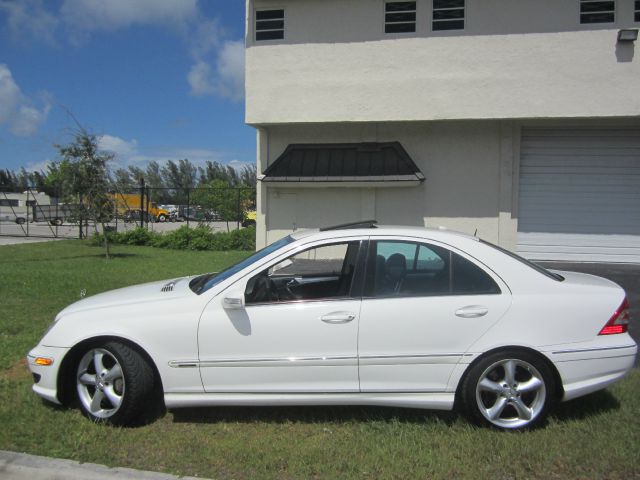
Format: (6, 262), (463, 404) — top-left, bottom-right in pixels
(0, 0), (255, 170)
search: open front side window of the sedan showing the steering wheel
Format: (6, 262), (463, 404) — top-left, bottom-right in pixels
(245, 241), (360, 305)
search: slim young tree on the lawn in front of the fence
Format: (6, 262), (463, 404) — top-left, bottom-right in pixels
(55, 128), (114, 258)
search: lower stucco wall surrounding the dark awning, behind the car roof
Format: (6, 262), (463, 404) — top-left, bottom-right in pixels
(258, 121), (516, 247)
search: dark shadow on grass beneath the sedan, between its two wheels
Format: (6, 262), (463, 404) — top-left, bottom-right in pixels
(171, 406), (459, 425)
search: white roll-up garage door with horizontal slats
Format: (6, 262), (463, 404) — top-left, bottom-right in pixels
(518, 127), (640, 263)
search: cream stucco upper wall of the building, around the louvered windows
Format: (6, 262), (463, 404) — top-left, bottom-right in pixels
(246, 0), (640, 125)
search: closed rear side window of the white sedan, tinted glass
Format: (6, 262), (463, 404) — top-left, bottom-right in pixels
(365, 241), (500, 298)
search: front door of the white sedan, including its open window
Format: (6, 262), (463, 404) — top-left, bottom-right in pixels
(198, 239), (364, 393)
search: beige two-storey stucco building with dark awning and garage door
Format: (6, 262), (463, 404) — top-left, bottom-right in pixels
(246, 0), (640, 262)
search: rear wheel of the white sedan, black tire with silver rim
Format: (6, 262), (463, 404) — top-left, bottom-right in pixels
(458, 349), (557, 430)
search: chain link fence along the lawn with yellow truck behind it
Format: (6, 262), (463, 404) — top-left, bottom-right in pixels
(0, 183), (256, 238)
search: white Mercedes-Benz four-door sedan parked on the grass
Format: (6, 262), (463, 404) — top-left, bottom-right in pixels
(28, 222), (637, 429)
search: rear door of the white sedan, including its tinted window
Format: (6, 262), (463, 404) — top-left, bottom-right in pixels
(358, 238), (511, 392)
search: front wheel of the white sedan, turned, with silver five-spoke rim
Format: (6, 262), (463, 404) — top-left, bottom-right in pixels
(74, 341), (159, 426)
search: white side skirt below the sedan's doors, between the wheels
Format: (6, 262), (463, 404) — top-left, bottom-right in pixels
(164, 393), (455, 410)
